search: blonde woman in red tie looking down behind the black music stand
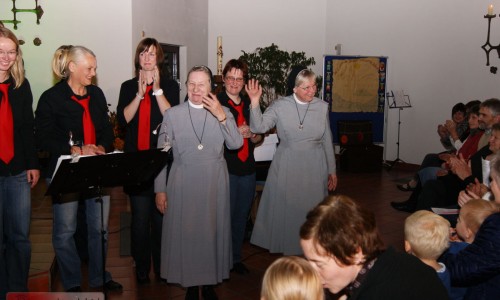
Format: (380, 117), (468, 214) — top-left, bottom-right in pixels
(35, 46), (122, 292)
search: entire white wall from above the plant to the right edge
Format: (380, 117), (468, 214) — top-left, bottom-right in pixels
(208, 0), (500, 163)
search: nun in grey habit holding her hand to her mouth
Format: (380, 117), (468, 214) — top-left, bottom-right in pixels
(155, 66), (243, 300)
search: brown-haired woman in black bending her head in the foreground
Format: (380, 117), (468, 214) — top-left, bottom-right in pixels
(300, 196), (448, 300)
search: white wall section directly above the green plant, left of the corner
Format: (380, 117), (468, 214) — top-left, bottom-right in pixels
(208, 0), (328, 74)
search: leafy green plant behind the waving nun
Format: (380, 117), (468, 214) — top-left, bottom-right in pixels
(240, 44), (322, 108)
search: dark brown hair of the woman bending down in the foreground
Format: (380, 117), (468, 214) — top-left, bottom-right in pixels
(300, 195), (384, 266)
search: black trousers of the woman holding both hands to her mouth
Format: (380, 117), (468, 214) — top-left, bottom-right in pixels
(129, 194), (163, 276)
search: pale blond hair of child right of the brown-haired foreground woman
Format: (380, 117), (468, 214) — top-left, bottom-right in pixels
(405, 210), (450, 259)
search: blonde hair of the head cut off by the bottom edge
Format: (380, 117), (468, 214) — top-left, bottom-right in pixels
(260, 256), (325, 300)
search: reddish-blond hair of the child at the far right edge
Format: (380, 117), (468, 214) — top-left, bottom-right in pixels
(460, 199), (499, 235)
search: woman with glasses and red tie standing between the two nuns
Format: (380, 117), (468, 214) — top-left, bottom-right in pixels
(217, 59), (262, 274)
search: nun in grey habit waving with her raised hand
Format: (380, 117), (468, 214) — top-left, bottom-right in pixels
(246, 68), (337, 255)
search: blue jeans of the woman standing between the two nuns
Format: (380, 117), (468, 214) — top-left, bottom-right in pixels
(229, 173), (255, 264)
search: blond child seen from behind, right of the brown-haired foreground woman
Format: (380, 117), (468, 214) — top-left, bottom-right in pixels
(405, 210), (465, 300)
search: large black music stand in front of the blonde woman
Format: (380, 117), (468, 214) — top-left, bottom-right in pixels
(45, 149), (169, 296)
